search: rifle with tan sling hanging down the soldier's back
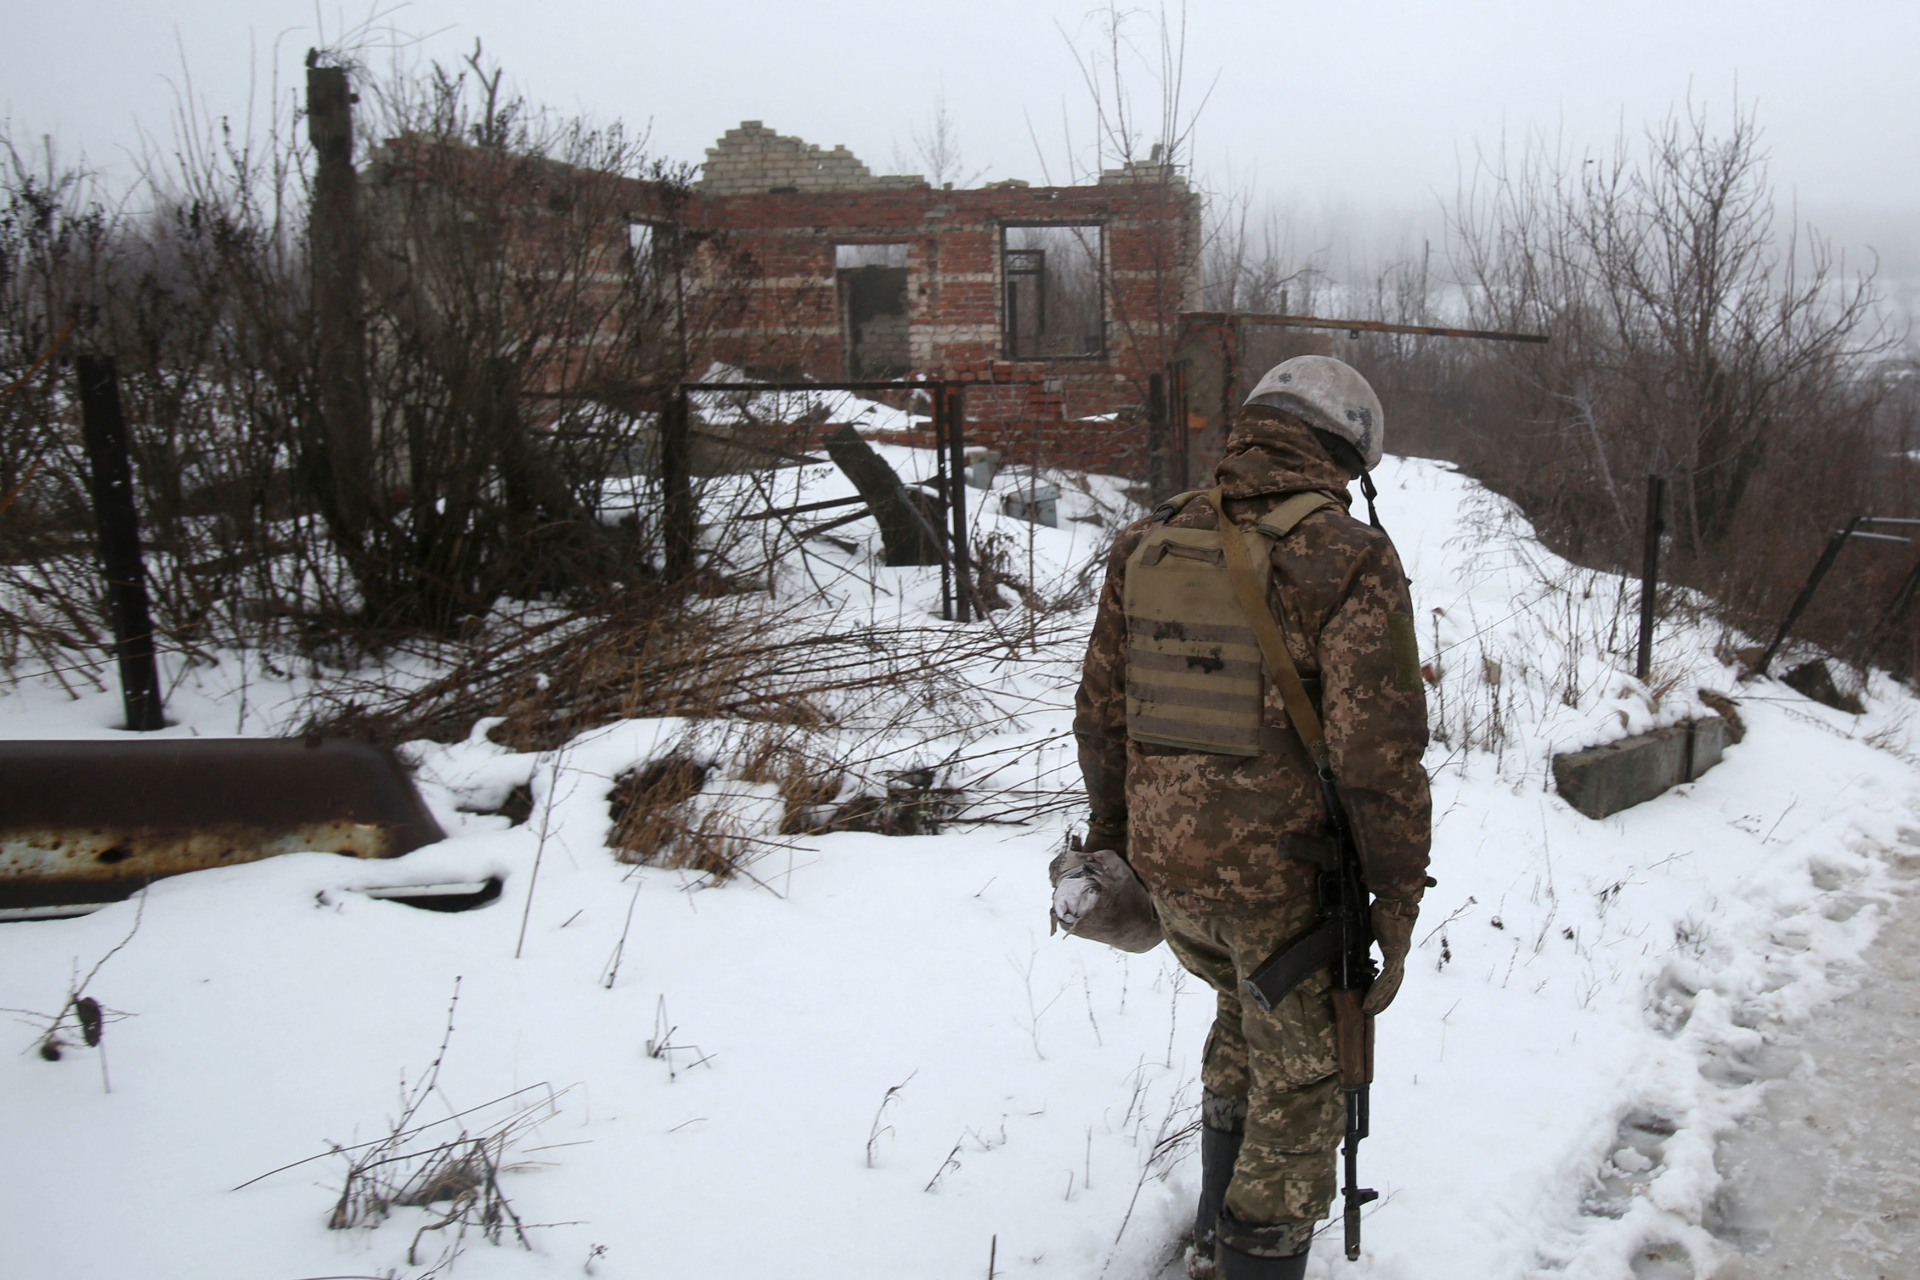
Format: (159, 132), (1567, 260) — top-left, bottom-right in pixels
(1210, 489), (1380, 1261)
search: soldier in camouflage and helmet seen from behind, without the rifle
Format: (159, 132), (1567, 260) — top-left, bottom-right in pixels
(1073, 355), (1432, 1280)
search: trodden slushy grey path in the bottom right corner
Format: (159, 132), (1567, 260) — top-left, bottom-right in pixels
(1715, 850), (1920, 1280)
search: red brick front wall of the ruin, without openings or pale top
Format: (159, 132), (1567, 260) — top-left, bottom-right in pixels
(687, 182), (1198, 476)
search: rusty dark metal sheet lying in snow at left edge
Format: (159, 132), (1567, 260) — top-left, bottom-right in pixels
(0, 737), (445, 908)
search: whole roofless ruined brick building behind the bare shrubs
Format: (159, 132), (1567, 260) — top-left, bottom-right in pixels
(363, 121), (1233, 487)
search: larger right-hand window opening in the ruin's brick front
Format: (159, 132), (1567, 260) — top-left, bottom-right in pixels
(1000, 225), (1106, 361)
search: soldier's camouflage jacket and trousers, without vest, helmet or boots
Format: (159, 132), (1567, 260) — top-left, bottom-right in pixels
(1073, 407), (1430, 1224)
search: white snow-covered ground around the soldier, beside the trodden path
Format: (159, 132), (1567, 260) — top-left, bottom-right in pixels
(0, 447), (1920, 1280)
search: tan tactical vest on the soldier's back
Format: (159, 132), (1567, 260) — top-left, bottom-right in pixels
(1123, 489), (1338, 756)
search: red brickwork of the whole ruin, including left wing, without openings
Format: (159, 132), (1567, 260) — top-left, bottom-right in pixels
(366, 138), (1200, 478)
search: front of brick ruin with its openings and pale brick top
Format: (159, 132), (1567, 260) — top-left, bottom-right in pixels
(680, 121), (1200, 478)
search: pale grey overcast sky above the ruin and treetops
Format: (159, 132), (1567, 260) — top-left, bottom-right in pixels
(0, 0), (1920, 269)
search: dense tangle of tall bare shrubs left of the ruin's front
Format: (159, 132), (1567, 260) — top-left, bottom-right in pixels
(0, 37), (783, 670)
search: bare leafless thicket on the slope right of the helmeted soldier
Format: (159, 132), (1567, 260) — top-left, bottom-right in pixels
(1208, 104), (1920, 670)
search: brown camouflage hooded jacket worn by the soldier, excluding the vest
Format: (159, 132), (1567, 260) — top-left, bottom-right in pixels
(1073, 407), (1432, 910)
